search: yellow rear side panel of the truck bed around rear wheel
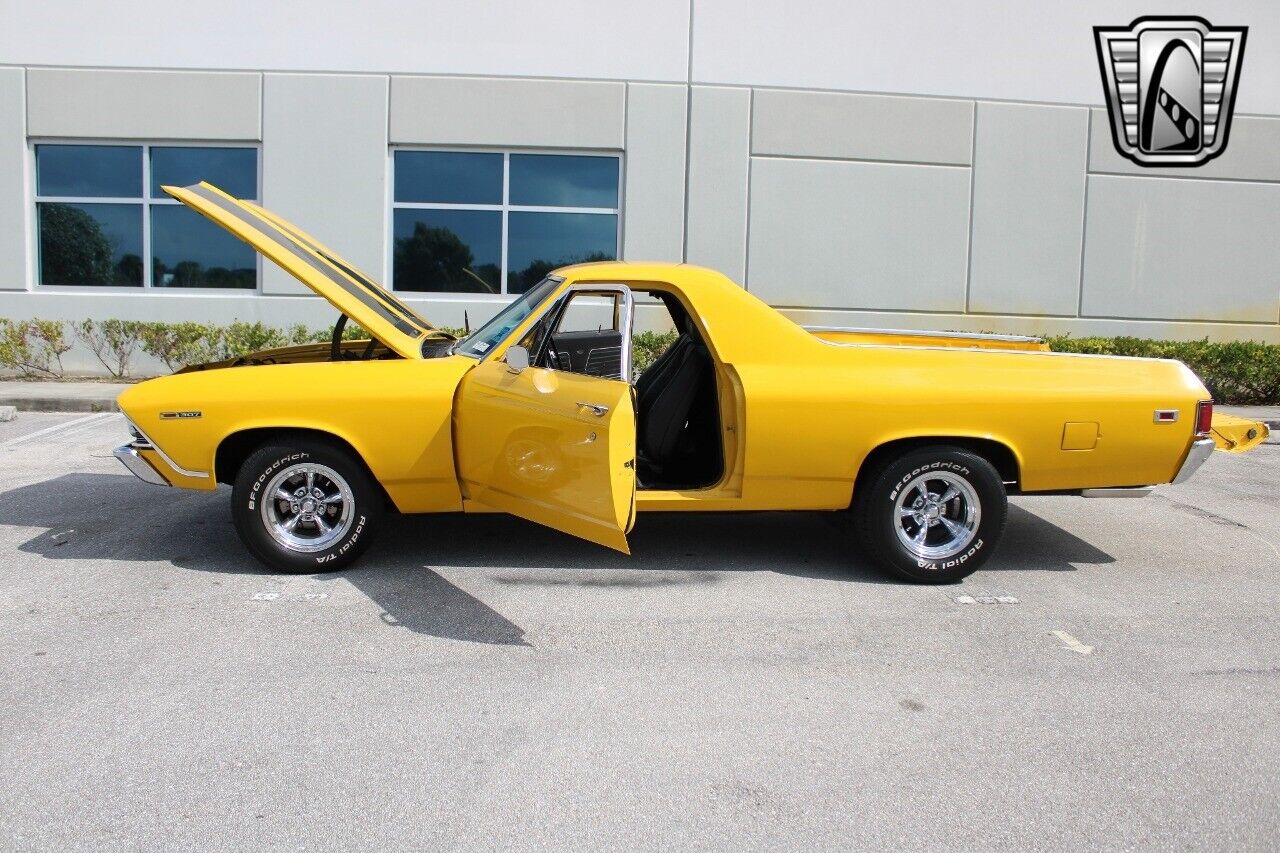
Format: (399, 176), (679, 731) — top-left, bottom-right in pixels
(737, 345), (1208, 506)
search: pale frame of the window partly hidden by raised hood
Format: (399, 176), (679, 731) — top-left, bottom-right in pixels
(27, 137), (262, 292)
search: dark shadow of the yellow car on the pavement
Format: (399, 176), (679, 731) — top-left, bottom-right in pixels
(0, 473), (1112, 637)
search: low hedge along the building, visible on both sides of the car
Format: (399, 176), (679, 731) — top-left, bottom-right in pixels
(0, 318), (1280, 405)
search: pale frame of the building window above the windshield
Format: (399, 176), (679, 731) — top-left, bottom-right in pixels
(384, 143), (626, 302)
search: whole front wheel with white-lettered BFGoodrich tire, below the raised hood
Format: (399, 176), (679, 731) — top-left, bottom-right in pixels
(232, 438), (381, 575)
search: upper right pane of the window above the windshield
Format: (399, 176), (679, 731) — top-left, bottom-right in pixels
(511, 154), (618, 207)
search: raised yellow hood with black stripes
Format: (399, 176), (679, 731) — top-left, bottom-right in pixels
(161, 182), (442, 359)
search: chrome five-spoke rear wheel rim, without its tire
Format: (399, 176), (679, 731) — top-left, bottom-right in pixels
(893, 471), (982, 560)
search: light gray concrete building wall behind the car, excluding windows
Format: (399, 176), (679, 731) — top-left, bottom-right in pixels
(0, 0), (1280, 373)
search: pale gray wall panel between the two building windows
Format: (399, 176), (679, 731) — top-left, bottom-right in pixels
(262, 74), (389, 293)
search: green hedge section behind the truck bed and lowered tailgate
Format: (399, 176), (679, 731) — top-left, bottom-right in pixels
(1044, 336), (1280, 406)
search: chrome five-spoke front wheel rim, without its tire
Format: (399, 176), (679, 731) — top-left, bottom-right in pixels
(260, 462), (356, 553)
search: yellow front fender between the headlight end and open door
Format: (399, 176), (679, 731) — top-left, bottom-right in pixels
(119, 356), (475, 512)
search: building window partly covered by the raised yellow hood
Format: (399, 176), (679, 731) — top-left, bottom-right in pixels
(36, 143), (257, 289)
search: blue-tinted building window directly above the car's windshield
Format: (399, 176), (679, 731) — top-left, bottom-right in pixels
(392, 149), (622, 293)
